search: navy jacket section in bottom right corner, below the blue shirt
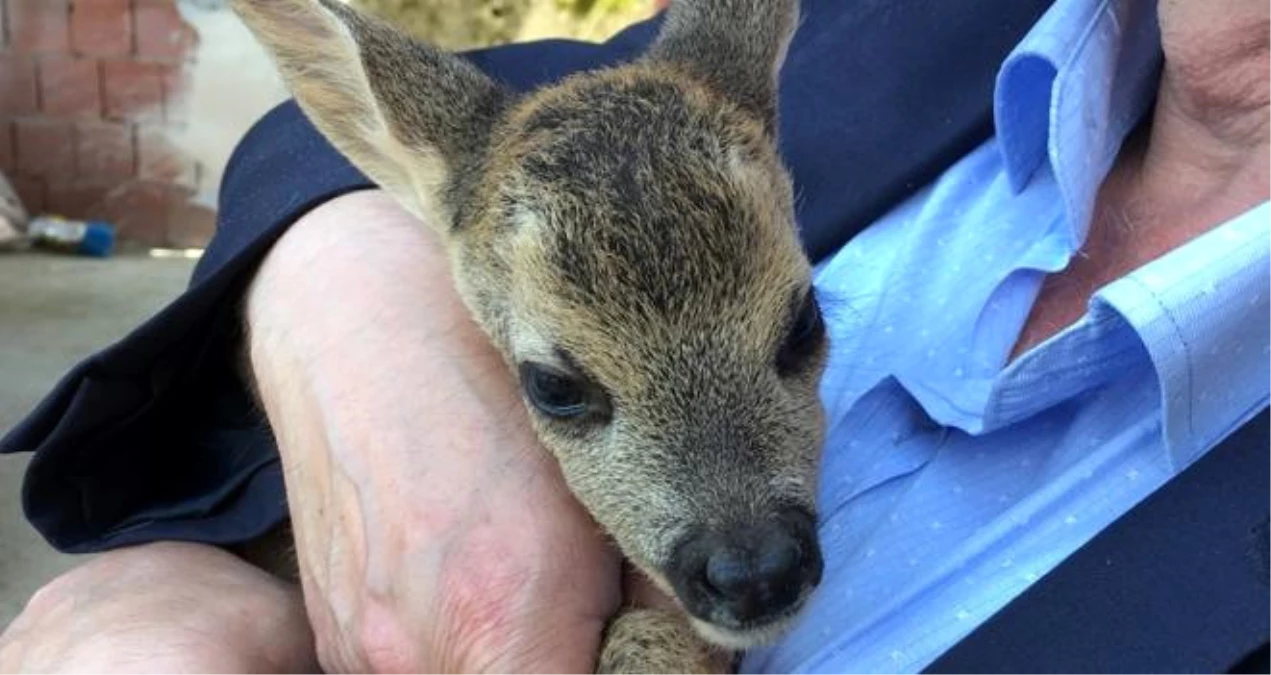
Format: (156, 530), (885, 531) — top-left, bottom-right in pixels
(928, 409), (1271, 675)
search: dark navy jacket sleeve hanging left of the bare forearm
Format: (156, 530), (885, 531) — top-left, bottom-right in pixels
(8, 106), (371, 553)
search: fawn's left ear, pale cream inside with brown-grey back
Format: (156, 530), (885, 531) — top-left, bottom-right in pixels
(234, 0), (507, 230)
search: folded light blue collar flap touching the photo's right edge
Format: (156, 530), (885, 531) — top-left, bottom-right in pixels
(1091, 201), (1271, 470)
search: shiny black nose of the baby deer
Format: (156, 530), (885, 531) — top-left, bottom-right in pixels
(669, 511), (821, 625)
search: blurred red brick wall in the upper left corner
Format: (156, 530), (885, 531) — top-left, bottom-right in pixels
(0, 0), (212, 247)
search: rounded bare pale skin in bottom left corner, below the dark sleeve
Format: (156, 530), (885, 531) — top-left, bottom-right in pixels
(0, 543), (318, 675)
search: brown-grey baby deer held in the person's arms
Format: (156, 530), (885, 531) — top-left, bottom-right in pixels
(234, 0), (827, 672)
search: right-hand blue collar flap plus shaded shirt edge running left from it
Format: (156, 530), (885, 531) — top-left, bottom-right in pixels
(982, 201), (1271, 470)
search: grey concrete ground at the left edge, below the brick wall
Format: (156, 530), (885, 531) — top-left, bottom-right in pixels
(0, 253), (194, 629)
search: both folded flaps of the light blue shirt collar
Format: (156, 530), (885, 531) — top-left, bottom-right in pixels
(994, 0), (1271, 469)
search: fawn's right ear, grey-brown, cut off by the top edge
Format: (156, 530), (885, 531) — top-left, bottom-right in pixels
(646, 0), (803, 131)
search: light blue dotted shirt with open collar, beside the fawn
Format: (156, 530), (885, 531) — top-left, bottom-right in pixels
(742, 0), (1271, 675)
